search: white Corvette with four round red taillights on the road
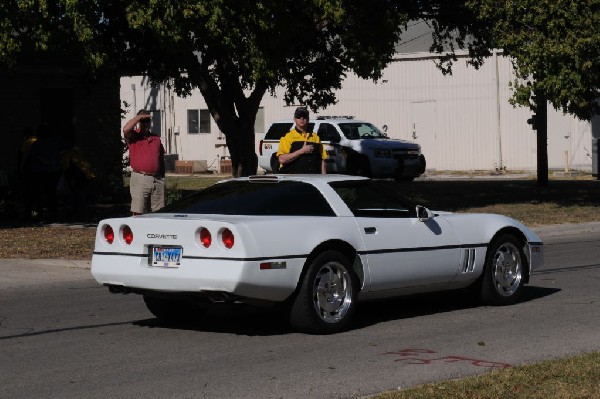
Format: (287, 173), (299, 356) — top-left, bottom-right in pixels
(92, 175), (543, 333)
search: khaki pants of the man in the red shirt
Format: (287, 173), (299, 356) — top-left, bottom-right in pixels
(129, 172), (165, 213)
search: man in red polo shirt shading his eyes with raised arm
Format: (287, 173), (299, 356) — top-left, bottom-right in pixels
(123, 109), (165, 215)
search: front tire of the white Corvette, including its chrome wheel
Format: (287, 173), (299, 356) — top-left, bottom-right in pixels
(481, 234), (528, 306)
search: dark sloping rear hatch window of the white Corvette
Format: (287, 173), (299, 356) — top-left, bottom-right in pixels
(160, 180), (335, 216)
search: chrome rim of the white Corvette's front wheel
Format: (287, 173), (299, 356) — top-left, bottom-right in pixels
(492, 242), (523, 297)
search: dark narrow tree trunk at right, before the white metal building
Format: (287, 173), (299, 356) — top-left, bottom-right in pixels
(527, 92), (548, 187)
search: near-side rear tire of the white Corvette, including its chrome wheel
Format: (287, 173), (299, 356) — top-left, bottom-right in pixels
(290, 250), (358, 334)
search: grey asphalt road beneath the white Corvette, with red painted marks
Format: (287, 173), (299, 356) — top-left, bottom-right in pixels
(0, 225), (600, 399)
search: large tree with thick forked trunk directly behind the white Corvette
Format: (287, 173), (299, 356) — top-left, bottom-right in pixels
(0, 0), (418, 175)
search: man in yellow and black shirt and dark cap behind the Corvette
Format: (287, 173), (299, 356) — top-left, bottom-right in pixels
(276, 107), (327, 174)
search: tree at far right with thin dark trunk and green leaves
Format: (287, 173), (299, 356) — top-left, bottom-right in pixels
(466, 0), (600, 185)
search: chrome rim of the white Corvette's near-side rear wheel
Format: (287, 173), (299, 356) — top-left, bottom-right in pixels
(312, 262), (353, 323)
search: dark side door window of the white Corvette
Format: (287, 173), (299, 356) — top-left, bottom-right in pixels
(331, 180), (415, 218)
